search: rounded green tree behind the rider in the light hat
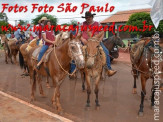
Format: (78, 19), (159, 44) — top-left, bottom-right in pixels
(32, 13), (57, 25)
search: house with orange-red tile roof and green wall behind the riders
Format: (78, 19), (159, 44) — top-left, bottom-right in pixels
(100, 9), (151, 39)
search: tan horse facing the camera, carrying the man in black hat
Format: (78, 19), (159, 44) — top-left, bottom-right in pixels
(81, 32), (106, 108)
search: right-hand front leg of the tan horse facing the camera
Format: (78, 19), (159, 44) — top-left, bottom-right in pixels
(94, 75), (100, 108)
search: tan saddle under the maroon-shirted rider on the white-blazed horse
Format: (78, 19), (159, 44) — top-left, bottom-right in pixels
(32, 47), (54, 62)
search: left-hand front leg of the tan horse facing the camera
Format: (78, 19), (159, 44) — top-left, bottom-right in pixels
(86, 75), (91, 107)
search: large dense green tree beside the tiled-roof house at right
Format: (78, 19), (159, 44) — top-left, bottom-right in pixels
(127, 12), (163, 36)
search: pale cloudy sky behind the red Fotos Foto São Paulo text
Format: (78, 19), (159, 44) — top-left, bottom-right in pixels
(0, 0), (151, 25)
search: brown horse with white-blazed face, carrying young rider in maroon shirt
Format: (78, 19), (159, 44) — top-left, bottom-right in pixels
(29, 34), (85, 112)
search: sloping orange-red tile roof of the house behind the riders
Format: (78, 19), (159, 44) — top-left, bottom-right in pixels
(100, 9), (151, 24)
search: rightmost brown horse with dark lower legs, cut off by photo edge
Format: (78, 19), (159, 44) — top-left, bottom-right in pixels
(130, 34), (163, 116)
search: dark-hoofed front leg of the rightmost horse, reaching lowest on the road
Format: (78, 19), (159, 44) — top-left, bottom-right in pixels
(138, 74), (147, 116)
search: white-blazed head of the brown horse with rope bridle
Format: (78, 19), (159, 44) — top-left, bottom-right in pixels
(69, 34), (85, 69)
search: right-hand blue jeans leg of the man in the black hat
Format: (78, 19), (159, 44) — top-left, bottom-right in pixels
(100, 42), (111, 69)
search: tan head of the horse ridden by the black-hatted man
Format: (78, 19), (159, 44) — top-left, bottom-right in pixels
(85, 32), (103, 68)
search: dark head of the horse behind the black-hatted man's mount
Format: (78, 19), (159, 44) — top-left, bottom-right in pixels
(111, 35), (126, 47)
